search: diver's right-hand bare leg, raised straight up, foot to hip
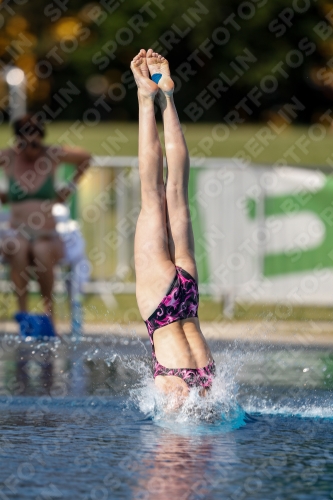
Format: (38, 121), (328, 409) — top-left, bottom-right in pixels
(147, 49), (197, 279)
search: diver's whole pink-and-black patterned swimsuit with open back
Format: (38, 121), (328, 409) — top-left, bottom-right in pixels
(145, 266), (215, 388)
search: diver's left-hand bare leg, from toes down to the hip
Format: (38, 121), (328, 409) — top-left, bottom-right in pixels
(131, 50), (175, 319)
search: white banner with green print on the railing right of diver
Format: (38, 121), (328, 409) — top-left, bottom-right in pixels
(191, 161), (333, 305)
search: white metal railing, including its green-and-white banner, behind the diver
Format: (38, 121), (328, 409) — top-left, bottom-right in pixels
(0, 156), (333, 320)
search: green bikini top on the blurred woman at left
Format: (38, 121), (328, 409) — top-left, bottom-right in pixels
(8, 150), (56, 203)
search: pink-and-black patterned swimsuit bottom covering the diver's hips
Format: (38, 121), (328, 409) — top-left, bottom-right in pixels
(145, 266), (199, 352)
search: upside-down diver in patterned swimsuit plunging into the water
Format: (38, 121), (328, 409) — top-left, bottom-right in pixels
(131, 49), (215, 396)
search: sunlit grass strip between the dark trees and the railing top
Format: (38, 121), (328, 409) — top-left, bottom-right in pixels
(0, 122), (332, 166)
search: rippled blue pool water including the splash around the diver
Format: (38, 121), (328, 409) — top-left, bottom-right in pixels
(0, 336), (333, 500)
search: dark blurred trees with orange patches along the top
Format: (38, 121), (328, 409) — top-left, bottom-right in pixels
(0, 0), (333, 121)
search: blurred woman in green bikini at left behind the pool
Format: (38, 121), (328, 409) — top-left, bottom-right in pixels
(0, 114), (91, 330)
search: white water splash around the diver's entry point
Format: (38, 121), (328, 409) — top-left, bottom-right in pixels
(68, 330), (246, 434)
